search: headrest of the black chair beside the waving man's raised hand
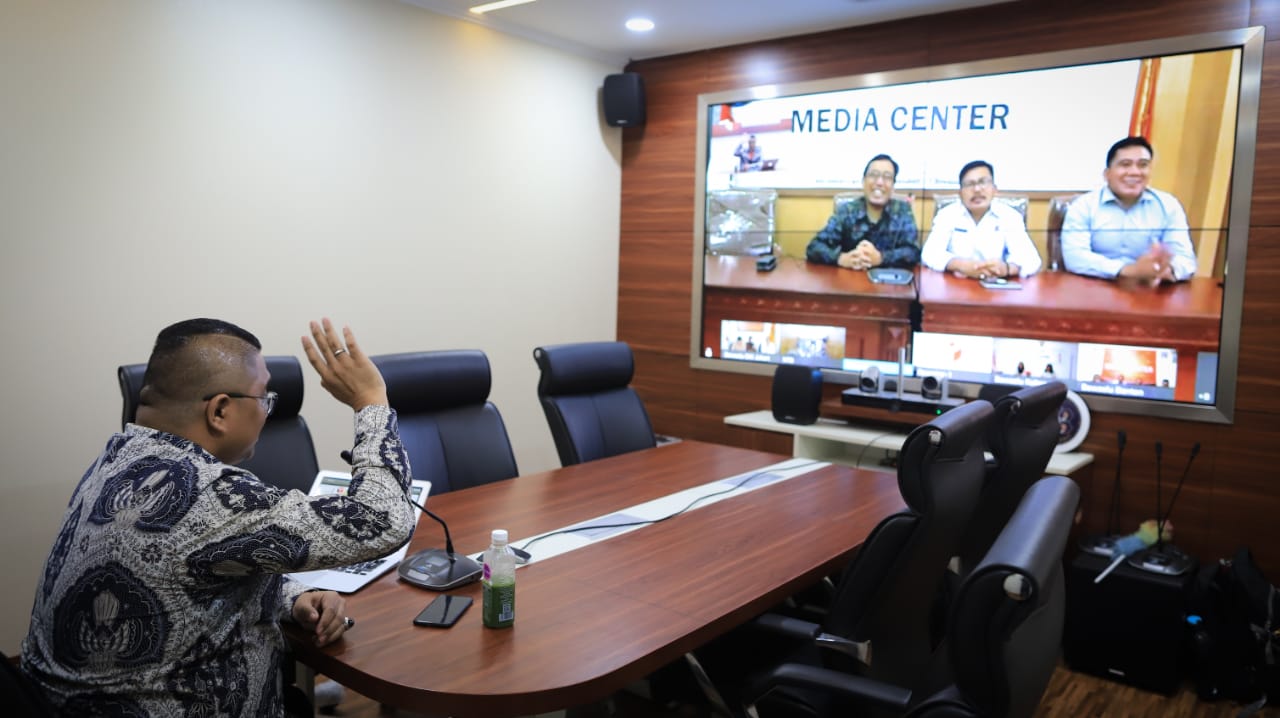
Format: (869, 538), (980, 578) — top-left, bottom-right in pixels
(370, 349), (492, 413)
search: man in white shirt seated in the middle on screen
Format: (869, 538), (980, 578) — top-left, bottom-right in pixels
(920, 160), (1042, 279)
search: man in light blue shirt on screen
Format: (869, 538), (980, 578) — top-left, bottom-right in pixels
(1062, 137), (1196, 285)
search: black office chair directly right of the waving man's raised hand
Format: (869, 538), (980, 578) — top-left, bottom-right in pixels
(370, 349), (520, 494)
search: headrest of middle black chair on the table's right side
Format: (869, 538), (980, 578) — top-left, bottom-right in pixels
(897, 399), (995, 512)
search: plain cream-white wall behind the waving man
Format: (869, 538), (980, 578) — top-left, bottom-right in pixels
(0, 0), (621, 655)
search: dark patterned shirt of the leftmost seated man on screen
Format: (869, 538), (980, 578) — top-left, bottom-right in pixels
(805, 197), (920, 269)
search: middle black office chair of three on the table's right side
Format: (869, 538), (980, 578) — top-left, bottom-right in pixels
(694, 399), (993, 715)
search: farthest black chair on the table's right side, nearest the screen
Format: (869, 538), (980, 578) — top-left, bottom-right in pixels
(957, 381), (1066, 576)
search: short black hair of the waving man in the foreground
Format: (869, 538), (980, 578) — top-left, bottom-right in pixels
(141, 319), (262, 404)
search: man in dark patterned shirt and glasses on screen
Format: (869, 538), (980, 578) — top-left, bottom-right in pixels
(805, 155), (920, 269)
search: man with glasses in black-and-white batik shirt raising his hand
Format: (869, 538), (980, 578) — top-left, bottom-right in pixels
(22, 319), (415, 718)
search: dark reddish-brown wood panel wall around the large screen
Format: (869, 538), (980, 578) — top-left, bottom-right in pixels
(618, 0), (1280, 573)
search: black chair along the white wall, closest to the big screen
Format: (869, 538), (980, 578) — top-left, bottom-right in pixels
(534, 342), (657, 466)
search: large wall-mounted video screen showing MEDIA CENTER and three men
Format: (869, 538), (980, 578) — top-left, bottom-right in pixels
(690, 28), (1263, 422)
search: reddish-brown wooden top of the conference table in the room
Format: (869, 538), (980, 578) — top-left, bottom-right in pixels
(285, 442), (904, 717)
